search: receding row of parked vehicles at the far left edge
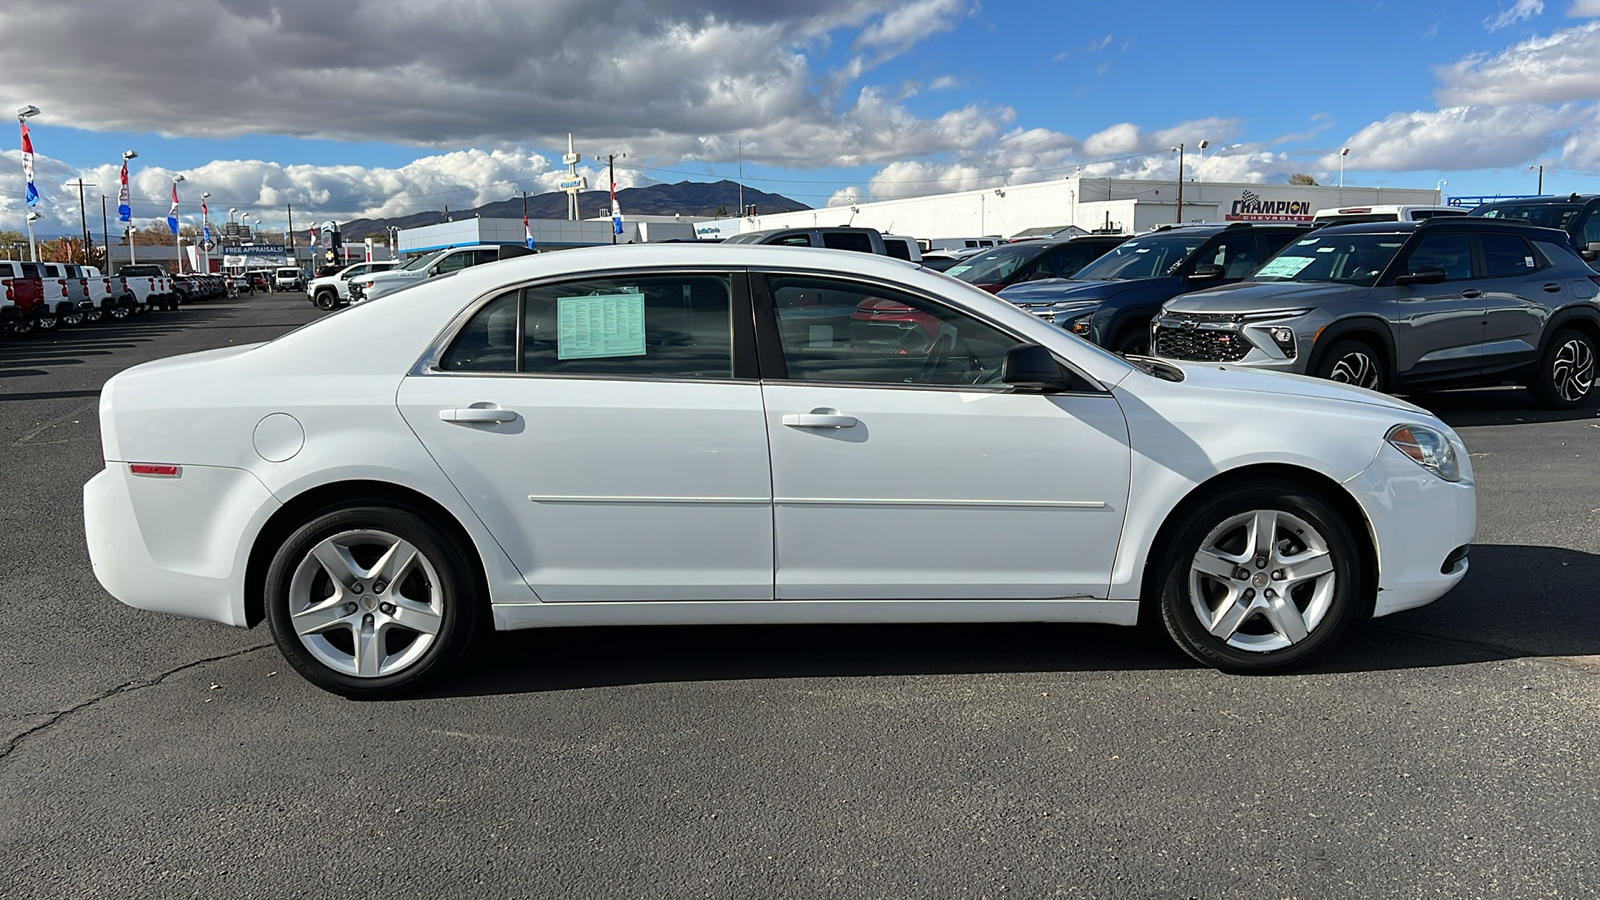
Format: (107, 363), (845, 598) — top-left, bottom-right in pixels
(0, 259), (227, 335)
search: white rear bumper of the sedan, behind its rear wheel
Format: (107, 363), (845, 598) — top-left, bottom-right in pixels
(83, 461), (282, 626)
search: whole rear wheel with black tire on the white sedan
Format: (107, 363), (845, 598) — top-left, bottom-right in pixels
(266, 503), (485, 700)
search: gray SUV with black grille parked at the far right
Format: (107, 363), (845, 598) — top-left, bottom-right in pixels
(1150, 216), (1600, 408)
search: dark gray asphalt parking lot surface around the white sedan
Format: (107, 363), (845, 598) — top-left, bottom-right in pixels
(0, 295), (1600, 898)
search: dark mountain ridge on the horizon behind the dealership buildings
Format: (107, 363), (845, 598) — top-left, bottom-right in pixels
(339, 179), (811, 240)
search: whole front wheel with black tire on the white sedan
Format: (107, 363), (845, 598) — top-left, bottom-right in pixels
(1154, 479), (1362, 674)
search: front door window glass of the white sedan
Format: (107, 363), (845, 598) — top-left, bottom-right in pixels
(768, 275), (1021, 386)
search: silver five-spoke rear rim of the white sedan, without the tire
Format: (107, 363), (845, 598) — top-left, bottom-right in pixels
(290, 528), (445, 677)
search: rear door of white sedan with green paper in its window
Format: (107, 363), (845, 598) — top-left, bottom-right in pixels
(398, 272), (773, 601)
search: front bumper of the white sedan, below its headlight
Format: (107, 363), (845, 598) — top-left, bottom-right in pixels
(1346, 442), (1478, 617)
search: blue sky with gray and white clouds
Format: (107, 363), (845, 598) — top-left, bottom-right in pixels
(0, 0), (1600, 234)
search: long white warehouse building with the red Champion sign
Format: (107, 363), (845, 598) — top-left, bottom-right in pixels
(694, 176), (1443, 239)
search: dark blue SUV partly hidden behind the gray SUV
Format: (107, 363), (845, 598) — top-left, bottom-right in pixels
(1000, 223), (1310, 354)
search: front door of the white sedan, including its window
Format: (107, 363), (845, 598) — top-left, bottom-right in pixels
(757, 274), (1130, 601)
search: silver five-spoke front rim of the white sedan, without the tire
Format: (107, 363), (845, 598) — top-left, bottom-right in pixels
(1189, 509), (1334, 653)
